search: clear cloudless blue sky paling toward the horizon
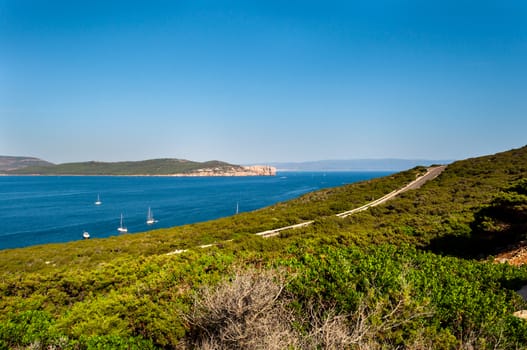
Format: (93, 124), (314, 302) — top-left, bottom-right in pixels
(0, 0), (527, 164)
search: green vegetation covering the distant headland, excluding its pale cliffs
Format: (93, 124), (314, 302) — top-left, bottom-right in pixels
(6, 159), (243, 175)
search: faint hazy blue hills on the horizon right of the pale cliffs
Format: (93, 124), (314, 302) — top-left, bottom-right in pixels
(270, 158), (452, 171)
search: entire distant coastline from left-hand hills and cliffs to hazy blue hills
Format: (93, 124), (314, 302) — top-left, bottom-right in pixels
(0, 156), (453, 177)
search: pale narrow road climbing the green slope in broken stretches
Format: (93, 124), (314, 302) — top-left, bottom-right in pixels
(167, 165), (447, 255)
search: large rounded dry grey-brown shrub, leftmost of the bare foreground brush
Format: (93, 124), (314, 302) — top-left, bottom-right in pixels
(186, 270), (298, 349)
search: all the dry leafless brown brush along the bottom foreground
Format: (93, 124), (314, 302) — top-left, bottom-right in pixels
(185, 270), (440, 350)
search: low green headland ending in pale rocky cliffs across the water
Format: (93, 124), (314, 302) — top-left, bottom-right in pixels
(4, 158), (275, 176)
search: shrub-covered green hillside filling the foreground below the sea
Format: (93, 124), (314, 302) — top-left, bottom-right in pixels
(0, 147), (527, 349)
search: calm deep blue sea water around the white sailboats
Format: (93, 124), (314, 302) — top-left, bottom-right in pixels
(0, 172), (391, 249)
